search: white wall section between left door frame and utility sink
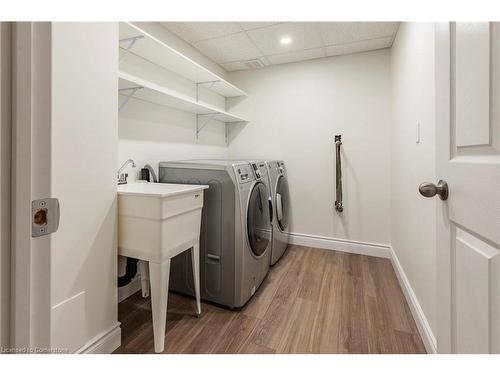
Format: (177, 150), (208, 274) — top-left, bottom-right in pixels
(51, 23), (118, 351)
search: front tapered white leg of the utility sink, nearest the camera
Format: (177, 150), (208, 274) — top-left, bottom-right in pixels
(149, 259), (170, 353)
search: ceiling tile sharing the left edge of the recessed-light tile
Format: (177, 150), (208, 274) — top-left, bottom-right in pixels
(193, 32), (262, 63)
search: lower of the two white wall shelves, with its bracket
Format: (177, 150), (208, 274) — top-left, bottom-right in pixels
(118, 72), (247, 123)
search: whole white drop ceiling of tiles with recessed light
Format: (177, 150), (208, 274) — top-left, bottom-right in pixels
(161, 22), (399, 71)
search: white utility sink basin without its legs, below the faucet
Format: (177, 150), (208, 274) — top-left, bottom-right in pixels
(118, 183), (208, 263)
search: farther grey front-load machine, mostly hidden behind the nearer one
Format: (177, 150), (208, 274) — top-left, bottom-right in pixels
(266, 160), (290, 265)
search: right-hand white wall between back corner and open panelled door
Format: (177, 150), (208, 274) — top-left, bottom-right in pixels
(391, 23), (437, 340)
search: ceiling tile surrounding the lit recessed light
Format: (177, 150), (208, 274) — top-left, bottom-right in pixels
(247, 22), (322, 55)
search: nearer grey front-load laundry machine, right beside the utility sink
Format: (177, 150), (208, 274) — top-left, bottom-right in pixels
(160, 160), (272, 308)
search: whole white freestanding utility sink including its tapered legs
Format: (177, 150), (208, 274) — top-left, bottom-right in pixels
(118, 183), (208, 353)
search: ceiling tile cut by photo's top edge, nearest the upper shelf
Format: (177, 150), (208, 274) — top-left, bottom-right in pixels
(161, 22), (242, 43)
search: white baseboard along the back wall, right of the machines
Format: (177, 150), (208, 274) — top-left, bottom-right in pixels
(289, 233), (391, 258)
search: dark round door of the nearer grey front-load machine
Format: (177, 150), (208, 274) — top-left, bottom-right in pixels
(247, 182), (271, 257)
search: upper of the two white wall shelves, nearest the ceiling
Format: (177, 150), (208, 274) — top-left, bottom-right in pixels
(120, 22), (247, 97)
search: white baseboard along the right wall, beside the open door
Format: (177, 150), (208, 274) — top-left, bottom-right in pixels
(390, 247), (437, 354)
